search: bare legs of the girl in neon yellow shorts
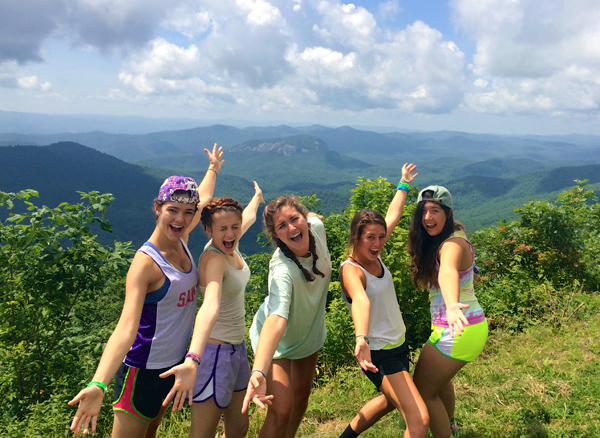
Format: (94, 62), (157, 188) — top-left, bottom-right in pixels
(414, 342), (466, 438)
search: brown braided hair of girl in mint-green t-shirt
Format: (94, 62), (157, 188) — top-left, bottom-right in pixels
(263, 195), (325, 281)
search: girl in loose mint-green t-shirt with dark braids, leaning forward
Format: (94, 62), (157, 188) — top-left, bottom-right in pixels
(243, 195), (331, 438)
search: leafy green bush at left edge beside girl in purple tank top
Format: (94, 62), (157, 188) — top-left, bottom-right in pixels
(0, 190), (132, 424)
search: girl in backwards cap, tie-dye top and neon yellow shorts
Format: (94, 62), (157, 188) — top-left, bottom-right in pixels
(408, 186), (488, 438)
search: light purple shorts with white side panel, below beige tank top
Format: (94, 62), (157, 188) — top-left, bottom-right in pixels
(193, 342), (250, 409)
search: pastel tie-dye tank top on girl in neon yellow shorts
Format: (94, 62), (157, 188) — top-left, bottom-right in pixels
(429, 230), (485, 327)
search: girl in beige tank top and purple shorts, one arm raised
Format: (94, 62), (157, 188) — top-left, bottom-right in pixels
(162, 182), (264, 438)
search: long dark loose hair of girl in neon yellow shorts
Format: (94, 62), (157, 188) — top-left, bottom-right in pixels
(408, 201), (464, 289)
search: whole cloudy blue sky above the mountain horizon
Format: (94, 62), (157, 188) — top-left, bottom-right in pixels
(0, 0), (600, 134)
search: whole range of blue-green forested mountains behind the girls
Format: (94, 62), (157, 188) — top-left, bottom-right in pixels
(0, 121), (600, 253)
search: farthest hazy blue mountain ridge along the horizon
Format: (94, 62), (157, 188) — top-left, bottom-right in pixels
(0, 125), (600, 165)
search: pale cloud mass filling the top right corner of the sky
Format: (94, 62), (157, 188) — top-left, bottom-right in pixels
(453, 0), (600, 114)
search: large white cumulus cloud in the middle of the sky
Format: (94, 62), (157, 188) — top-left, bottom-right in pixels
(112, 0), (465, 113)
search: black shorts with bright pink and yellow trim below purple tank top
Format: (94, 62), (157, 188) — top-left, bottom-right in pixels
(113, 363), (175, 423)
